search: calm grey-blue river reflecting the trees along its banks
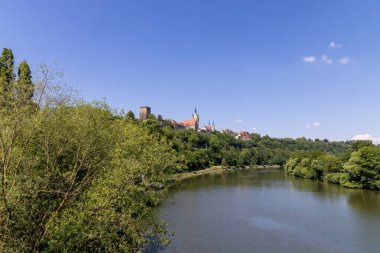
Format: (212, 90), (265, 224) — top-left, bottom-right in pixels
(159, 169), (380, 253)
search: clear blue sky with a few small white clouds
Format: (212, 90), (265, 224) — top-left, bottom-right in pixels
(0, 0), (380, 140)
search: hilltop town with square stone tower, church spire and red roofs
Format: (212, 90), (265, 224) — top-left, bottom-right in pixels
(139, 106), (251, 141)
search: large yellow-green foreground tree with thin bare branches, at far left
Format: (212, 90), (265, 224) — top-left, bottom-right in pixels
(1, 104), (118, 252)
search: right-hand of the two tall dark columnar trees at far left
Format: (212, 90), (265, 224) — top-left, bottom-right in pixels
(16, 61), (34, 105)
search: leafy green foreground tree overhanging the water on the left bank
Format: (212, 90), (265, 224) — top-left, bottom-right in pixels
(45, 124), (181, 252)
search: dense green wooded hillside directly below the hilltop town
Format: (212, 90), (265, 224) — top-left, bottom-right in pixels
(133, 115), (352, 170)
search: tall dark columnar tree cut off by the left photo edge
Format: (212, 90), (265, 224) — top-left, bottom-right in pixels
(0, 48), (15, 107)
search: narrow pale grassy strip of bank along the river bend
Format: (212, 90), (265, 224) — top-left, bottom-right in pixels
(176, 165), (281, 181)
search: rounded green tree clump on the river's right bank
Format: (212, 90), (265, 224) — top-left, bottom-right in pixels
(285, 141), (380, 190)
